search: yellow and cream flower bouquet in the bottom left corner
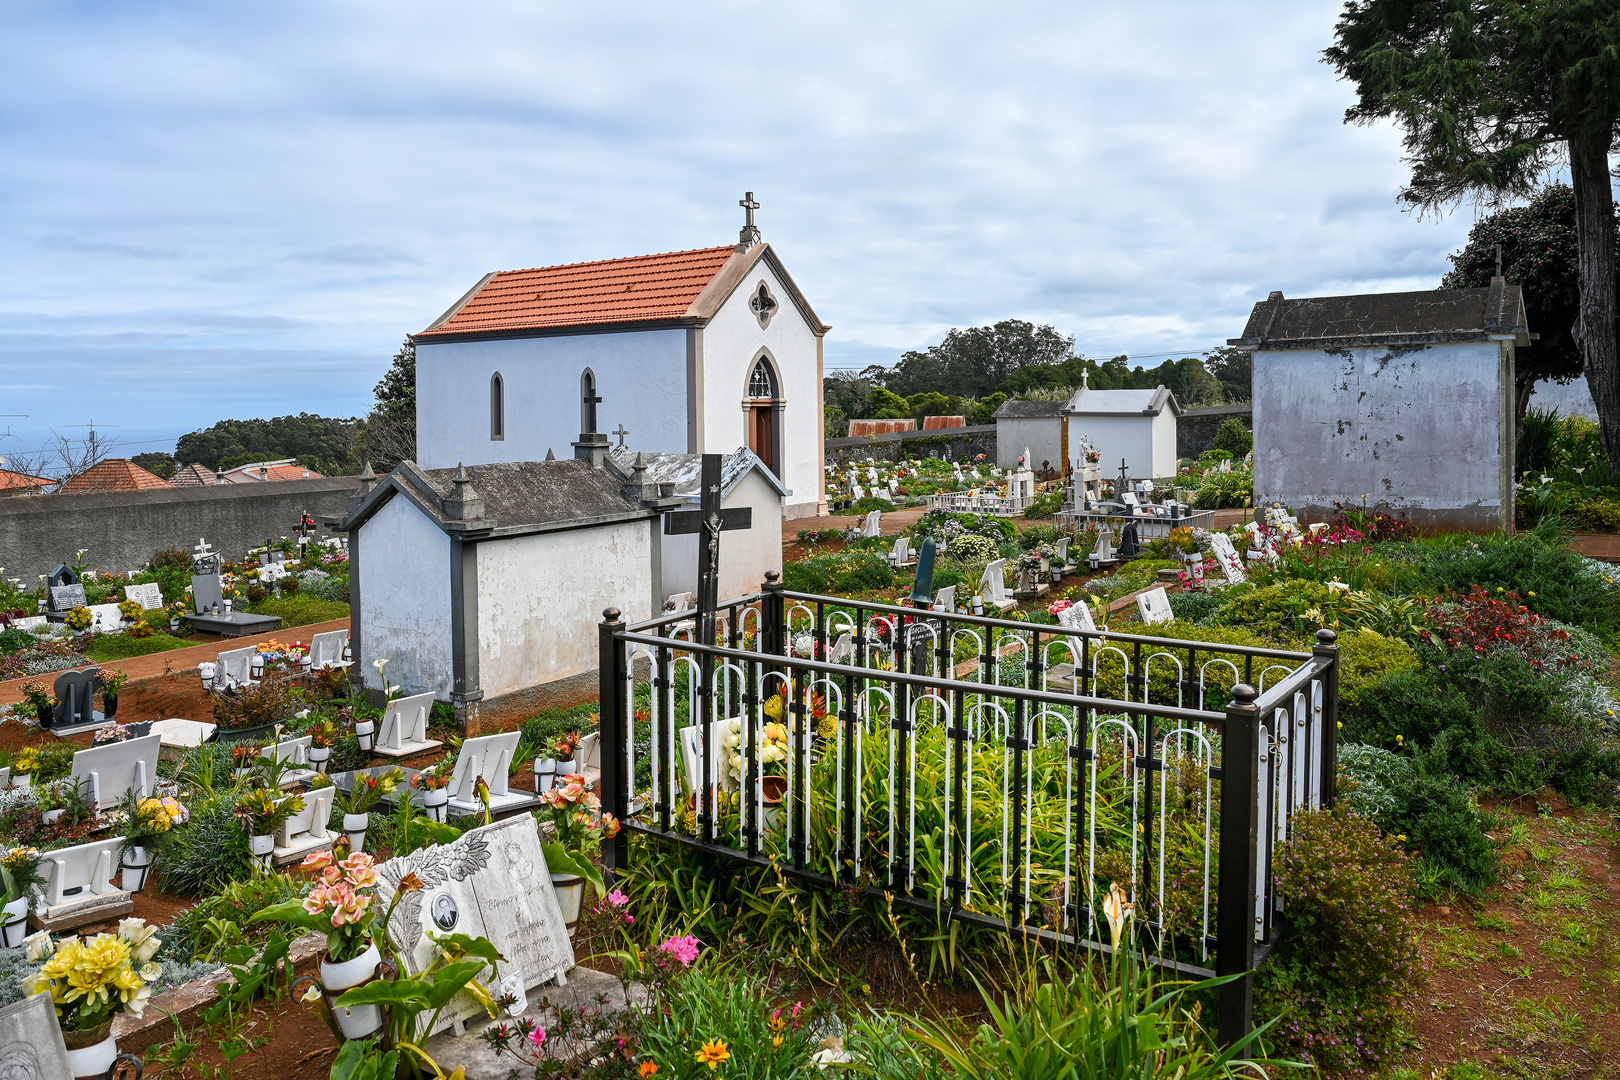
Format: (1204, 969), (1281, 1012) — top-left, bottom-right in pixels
(23, 918), (162, 1041)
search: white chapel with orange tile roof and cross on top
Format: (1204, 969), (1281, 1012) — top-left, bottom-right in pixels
(413, 191), (831, 518)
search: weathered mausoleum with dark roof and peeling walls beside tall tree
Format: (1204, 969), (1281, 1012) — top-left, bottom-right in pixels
(1228, 277), (1534, 531)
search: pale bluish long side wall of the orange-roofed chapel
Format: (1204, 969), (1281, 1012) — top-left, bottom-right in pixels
(416, 330), (686, 468)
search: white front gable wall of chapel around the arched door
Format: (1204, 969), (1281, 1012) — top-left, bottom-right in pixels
(703, 259), (825, 518)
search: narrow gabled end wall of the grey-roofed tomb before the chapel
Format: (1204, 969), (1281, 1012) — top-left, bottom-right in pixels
(355, 495), (452, 699)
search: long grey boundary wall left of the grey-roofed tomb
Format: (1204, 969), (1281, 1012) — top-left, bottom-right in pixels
(0, 476), (356, 586)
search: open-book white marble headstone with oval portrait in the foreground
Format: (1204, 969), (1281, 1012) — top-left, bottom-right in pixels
(377, 814), (573, 1031)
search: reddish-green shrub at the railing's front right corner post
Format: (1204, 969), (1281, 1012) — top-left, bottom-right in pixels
(1254, 806), (1421, 1077)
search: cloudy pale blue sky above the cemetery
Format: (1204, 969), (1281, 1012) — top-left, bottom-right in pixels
(0, 0), (1473, 466)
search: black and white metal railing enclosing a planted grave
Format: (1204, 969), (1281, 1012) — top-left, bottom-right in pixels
(599, 573), (1338, 1043)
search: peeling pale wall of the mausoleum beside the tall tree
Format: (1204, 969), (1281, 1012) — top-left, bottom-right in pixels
(1257, 342), (1511, 529)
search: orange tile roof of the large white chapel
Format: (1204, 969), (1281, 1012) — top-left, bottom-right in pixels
(416, 244), (735, 337)
